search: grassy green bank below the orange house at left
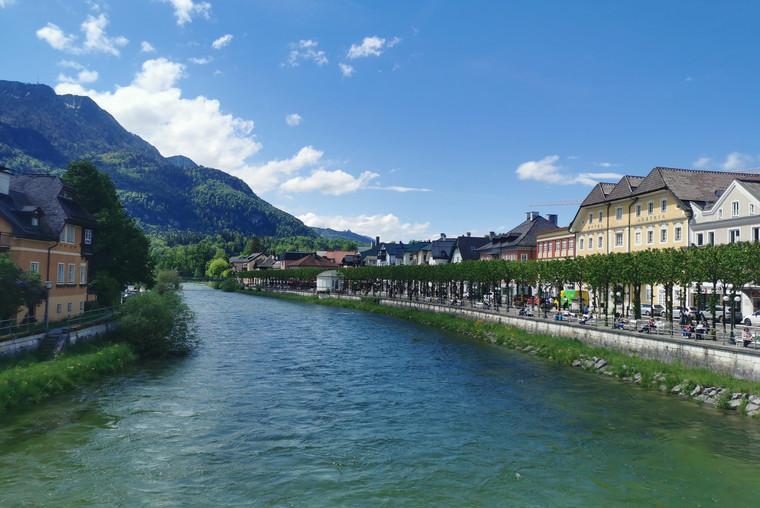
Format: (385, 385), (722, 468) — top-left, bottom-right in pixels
(0, 343), (137, 416)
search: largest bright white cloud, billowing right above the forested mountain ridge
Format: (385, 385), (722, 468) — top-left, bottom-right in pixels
(55, 58), (261, 172)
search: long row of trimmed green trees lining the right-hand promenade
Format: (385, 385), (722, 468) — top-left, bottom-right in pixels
(236, 242), (760, 325)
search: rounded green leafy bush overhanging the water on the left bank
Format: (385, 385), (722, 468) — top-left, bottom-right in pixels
(119, 291), (197, 358)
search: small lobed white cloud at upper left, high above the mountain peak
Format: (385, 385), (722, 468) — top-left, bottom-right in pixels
(36, 14), (129, 56)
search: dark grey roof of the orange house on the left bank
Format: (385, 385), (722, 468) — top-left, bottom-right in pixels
(0, 175), (96, 240)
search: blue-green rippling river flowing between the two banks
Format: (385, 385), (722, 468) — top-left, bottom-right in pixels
(0, 285), (760, 507)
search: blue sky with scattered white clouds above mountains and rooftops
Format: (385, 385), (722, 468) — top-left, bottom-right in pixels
(0, 0), (760, 240)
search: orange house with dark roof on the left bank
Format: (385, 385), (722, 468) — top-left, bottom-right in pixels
(0, 167), (96, 321)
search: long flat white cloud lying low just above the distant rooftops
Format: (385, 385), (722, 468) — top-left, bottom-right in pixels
(298, 212), (430, 241)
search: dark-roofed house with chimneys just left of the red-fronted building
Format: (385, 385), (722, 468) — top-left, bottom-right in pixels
(477, 212), (559, 261)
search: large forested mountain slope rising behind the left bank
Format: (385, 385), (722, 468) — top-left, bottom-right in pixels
(0, 81), (314, 236)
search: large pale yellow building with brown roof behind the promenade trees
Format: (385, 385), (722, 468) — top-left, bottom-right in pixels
(570, 167), (760, 304)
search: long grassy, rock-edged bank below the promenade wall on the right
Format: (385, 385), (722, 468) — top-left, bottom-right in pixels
(241, 291), (760, 417)
